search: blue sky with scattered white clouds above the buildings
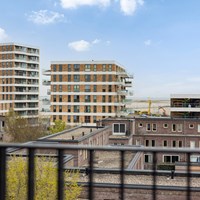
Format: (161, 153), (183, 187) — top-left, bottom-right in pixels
(0, 0), (200, 98)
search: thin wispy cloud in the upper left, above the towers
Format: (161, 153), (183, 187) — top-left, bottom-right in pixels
(28, 10), (64, 24)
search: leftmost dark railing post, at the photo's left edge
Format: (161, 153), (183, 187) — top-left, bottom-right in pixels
(0, 147), (6, 200)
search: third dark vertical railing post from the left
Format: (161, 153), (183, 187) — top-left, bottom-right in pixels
(57, 149), (64, 200)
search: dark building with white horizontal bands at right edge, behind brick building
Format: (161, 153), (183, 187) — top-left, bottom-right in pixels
(170, 94), (200, 118)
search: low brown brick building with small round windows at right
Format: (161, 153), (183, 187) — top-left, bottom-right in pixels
(133, 118), (200, 167)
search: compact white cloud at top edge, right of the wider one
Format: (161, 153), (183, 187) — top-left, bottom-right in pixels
(120, 0), (144, 15)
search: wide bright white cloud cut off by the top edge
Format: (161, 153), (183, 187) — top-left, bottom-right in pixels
(60, 0), (111, 9)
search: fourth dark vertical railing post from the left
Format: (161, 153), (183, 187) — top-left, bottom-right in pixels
(89, 149), (94, 200)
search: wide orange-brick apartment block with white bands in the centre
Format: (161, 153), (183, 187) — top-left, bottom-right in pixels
(43, 61), (133, 125)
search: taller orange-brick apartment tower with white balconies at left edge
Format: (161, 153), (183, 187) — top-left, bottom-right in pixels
(0, 43), (40, 118)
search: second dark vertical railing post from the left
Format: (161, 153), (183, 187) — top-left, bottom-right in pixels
(28, 148), (35, 200)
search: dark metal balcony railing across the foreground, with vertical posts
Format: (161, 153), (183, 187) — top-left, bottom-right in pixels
(0, 143), (200, 200)
